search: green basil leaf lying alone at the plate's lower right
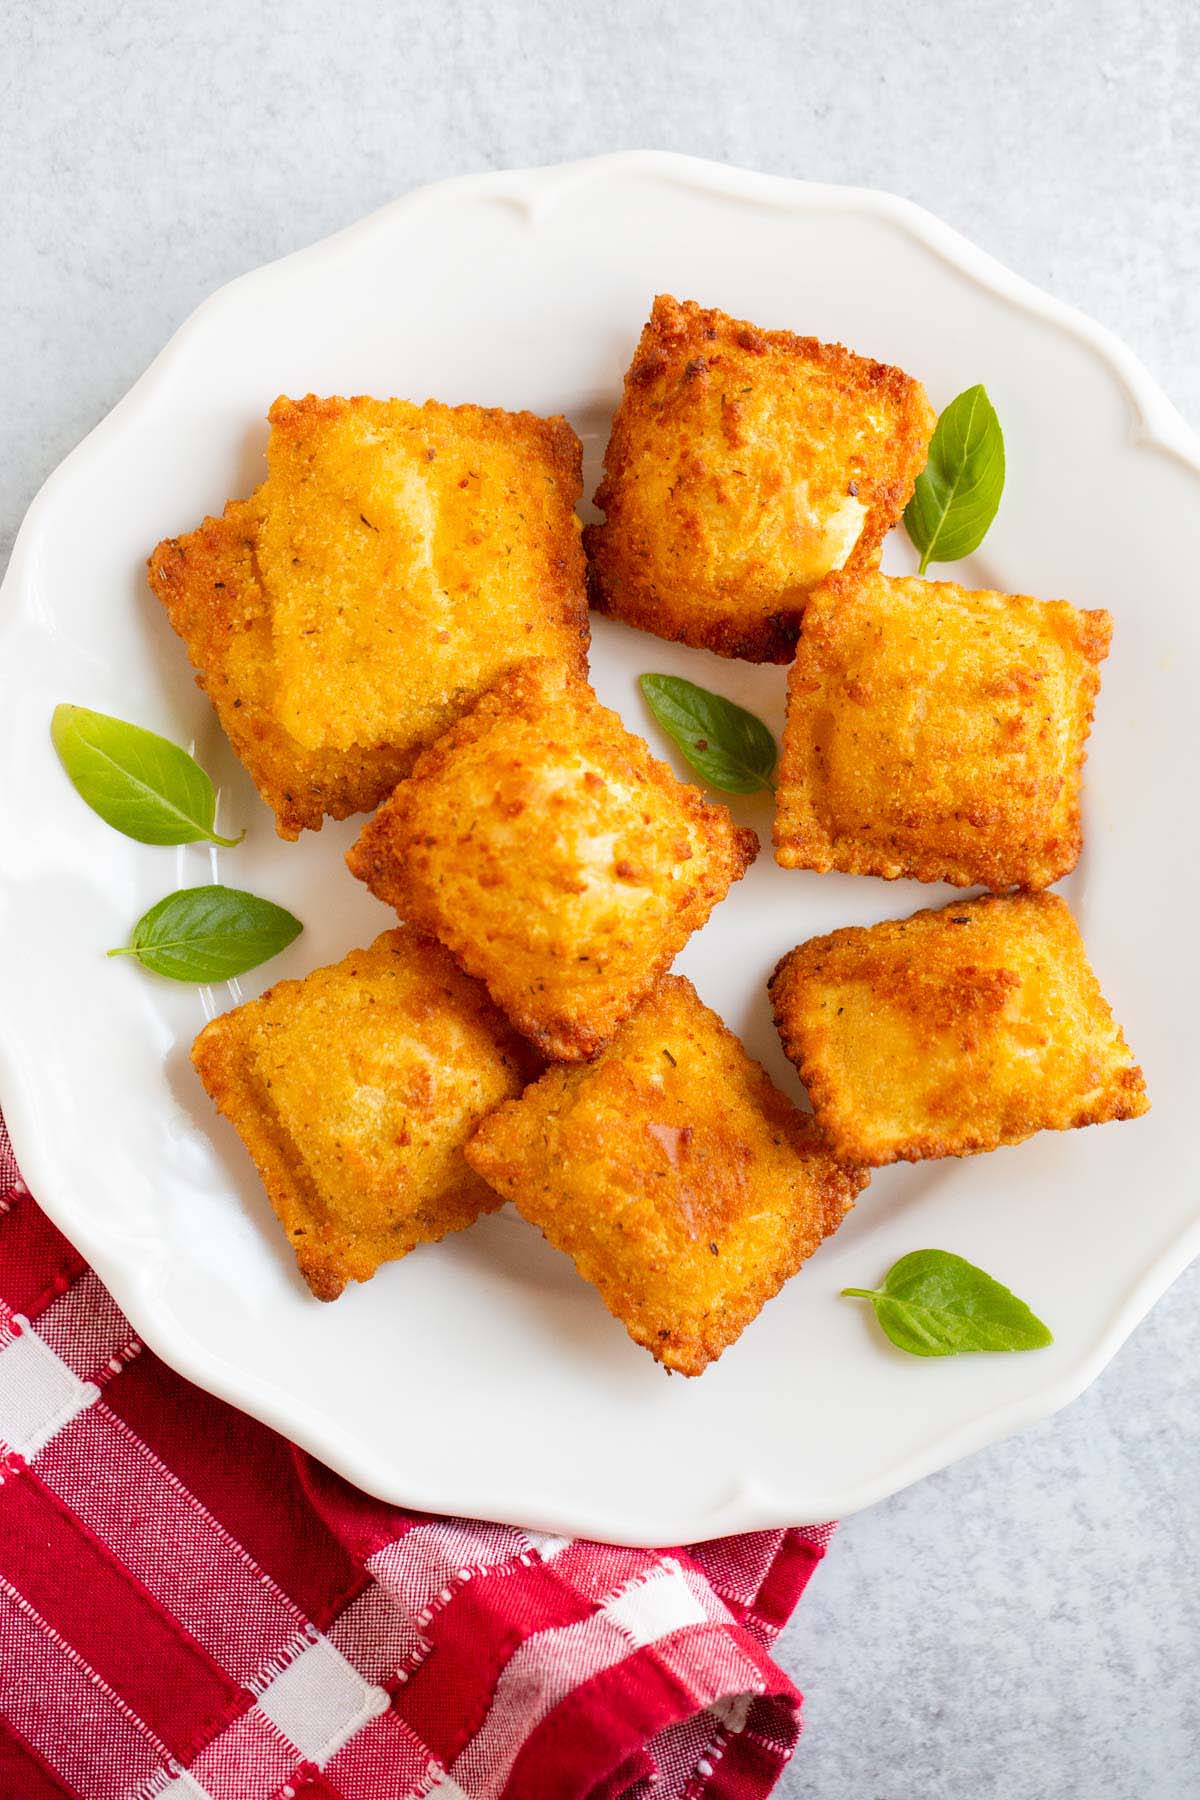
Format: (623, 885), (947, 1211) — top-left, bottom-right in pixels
(842, 1249), (1054, 1355)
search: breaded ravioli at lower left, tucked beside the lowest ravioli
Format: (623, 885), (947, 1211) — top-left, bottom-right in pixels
(193, 927), (542, 1300)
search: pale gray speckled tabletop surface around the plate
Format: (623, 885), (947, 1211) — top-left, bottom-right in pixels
(0, 0), (1200, 1800)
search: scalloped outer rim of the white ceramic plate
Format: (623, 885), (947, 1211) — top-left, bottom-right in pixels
(0, 151), (1200, 1544)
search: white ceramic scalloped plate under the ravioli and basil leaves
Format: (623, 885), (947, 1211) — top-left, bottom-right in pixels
(0, 155), (1200, 1543)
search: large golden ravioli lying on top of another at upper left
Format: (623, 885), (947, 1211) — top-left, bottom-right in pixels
(259, 394), (588, 749)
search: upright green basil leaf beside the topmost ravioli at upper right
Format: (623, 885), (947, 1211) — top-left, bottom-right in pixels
(905, 387), (1004, 574)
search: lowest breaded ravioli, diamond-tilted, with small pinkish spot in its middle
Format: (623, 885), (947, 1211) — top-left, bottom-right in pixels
(466, 976), (867, 1375)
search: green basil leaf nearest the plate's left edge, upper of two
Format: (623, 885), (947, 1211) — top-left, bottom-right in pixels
(50, 706), (246, 848)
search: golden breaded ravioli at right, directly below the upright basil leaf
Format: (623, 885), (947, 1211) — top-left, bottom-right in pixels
(775, 572), (1112, 887)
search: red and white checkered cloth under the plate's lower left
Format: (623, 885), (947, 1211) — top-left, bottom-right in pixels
(0, 1120), (829, 1800)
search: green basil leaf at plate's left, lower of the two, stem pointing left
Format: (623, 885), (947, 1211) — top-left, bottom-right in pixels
(108, 886), (304, 981)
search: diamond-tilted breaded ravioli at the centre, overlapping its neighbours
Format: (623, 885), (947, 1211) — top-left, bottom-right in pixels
(345, 662), (757, 1060)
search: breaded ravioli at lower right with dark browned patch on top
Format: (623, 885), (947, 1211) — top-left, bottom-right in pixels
(770, 893), (1150, 1166)
